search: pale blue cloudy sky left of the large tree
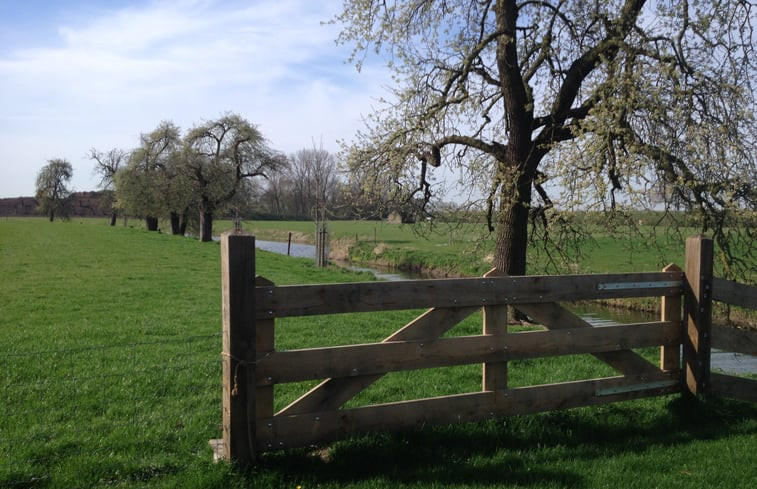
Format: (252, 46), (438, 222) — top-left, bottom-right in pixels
(0, 0), (390, 198)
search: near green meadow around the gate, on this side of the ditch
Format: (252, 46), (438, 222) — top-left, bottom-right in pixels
(0, 219), (757, 489)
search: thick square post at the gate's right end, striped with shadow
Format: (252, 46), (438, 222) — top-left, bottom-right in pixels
(683, 235), (713, 395)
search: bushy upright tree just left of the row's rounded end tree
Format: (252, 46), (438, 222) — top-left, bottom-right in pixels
(115, 121), (186, 231)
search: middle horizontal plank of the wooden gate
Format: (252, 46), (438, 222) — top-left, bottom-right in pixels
(256, 322), (681, 390)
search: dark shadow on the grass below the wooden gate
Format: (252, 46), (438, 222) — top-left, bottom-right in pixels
(248, 397), (757, 488)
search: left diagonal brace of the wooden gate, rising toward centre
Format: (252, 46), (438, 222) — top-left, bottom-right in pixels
(279, 307), (478, 415)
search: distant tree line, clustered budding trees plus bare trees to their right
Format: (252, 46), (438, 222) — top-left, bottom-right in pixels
(89, 113), (404, 241)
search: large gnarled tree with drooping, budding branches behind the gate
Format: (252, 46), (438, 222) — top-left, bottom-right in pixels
(335, 0), (757, 275)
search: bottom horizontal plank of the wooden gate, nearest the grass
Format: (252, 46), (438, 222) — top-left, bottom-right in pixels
(257, 372), (680, 450)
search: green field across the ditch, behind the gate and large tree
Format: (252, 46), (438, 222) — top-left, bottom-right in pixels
(216, 221), (694, 276)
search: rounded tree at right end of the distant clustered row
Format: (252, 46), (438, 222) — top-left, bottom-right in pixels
(182, 113), (285, 241)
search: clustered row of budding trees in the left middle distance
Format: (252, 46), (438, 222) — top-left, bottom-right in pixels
(90, 113), (287, 241)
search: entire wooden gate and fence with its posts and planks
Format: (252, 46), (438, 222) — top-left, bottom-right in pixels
(211, 234), (757, 465)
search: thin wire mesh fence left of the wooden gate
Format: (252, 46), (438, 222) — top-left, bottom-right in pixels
(0, 333), (221, 487)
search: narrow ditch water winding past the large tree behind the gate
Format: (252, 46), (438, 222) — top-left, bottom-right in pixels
(255, 239), (757, 375)
